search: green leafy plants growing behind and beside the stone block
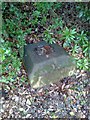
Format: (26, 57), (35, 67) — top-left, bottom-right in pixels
(0, 2), (90, 82)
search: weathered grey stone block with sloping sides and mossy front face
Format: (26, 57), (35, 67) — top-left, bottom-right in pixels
(24, 41), (75, 88)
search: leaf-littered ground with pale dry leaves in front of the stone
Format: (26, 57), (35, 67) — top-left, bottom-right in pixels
(0, 71), (90, 120)
